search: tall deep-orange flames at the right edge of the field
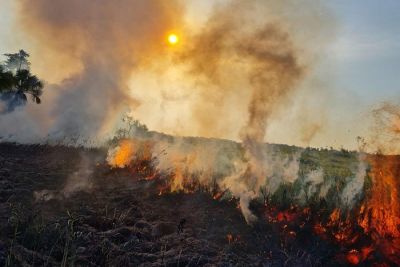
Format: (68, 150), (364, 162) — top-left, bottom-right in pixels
(320, 155), (400, 265)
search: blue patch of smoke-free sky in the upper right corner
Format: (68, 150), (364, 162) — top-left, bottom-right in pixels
(328, 0), (400, 102)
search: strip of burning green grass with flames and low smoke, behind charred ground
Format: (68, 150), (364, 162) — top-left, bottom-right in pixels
(107, 136), (400, 264)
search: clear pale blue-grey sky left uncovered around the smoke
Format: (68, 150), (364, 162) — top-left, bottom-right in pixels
(0, 0), (400, 151)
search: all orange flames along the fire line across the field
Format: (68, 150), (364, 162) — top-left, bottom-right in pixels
(107, 140), (400, 265)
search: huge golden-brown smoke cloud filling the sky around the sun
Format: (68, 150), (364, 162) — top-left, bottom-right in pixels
(0, 0), (333, 146)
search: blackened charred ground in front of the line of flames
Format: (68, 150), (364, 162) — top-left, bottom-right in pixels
(0, 143), (398, 266)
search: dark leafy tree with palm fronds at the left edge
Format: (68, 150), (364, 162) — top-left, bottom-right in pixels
(0, 50), (43, 113)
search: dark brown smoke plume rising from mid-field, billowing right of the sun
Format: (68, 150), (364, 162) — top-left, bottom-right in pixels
(176, 1), (306, 222)
